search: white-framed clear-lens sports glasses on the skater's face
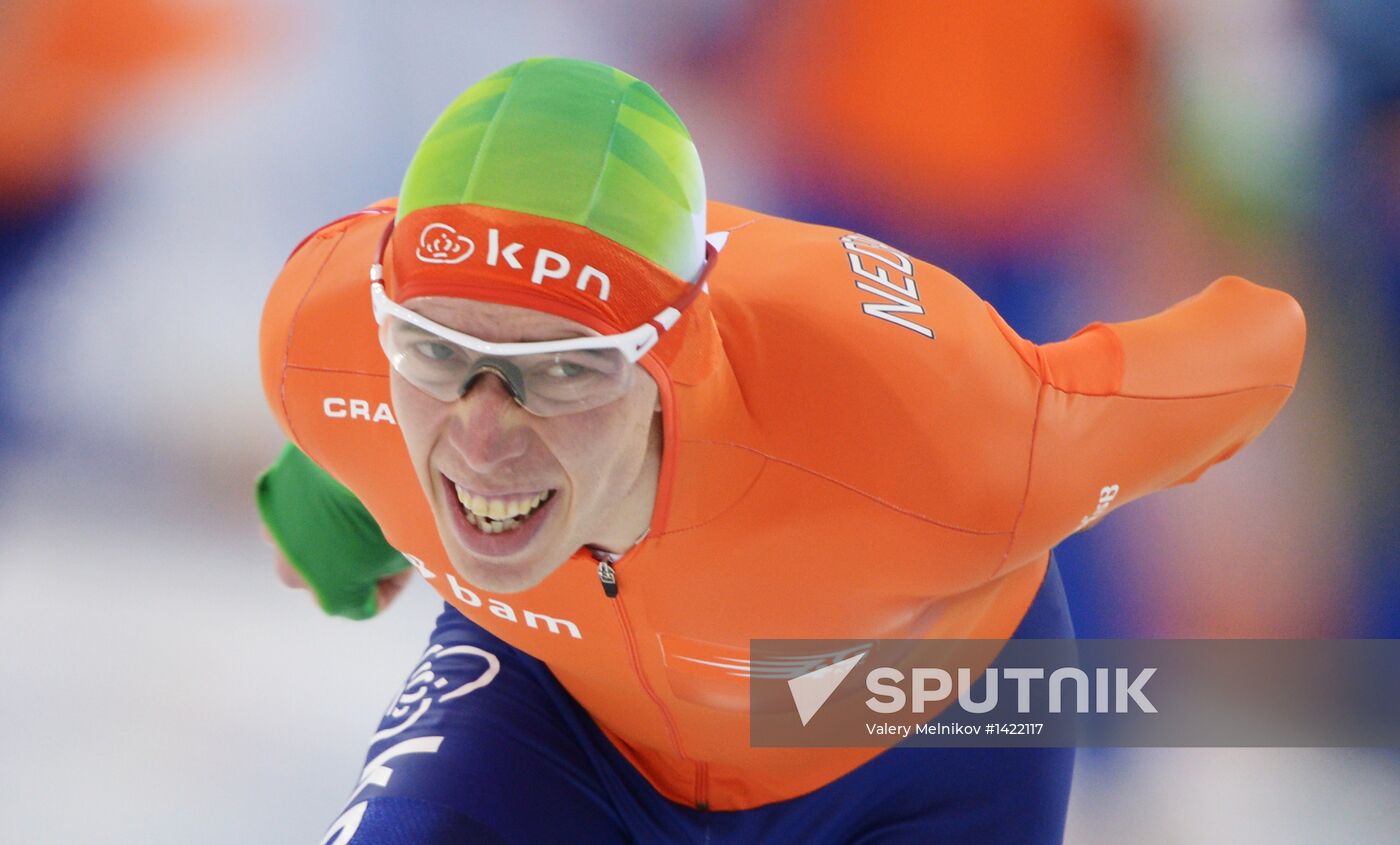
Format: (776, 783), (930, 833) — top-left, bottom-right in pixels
(370, 220), (718, 417)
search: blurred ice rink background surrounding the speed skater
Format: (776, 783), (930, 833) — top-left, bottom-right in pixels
(0, 0), (1400, 845)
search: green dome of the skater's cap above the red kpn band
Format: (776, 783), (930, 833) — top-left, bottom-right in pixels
(398, 59), (706, 280)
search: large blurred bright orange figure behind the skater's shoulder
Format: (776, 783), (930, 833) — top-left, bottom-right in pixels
(748, 0), (1147, 332)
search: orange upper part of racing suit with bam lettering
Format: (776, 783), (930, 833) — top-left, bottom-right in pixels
(262, 194), (1305, 810)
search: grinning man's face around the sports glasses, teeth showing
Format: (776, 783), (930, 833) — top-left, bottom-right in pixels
(391, 297), (661, 593)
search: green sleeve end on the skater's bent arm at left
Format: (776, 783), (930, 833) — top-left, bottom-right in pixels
(258, 443), (409, 620)
